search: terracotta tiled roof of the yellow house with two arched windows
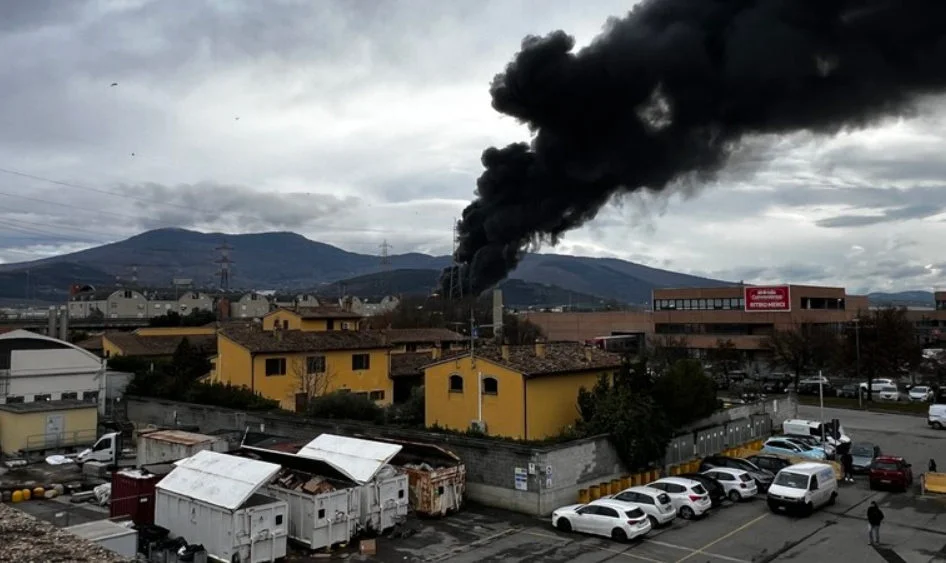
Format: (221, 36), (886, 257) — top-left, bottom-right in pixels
(428, 342), (622, 377)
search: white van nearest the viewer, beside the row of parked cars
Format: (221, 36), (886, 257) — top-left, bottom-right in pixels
(766, 463), (838, 514)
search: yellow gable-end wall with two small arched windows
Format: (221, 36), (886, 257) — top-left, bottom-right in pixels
(424, 356), (525, 439)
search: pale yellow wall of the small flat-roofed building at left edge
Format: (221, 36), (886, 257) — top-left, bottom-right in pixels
(0, 404), (98, 455)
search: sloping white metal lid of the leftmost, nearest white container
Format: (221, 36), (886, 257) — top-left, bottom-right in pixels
(156, 450), (280, 510)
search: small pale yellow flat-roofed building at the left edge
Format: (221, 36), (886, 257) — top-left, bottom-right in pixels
(0, 399), (98, 456)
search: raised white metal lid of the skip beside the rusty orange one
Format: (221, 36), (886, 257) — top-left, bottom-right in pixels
(297, 434), (401, 483)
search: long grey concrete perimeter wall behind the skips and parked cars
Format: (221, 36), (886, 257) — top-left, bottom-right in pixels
(126, 397), (794, 516)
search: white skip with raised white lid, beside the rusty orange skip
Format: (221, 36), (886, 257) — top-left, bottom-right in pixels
(297, 434), (409, 534)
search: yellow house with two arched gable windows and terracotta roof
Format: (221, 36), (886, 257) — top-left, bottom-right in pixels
(424, 342), (621, 440)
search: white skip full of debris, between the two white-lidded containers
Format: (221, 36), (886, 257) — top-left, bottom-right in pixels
(243, 446), (362, 549)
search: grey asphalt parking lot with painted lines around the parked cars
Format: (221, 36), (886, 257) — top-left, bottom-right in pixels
(356, 407), (946, 563)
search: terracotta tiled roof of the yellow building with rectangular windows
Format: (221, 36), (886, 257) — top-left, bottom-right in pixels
(220, 325), (388, 354)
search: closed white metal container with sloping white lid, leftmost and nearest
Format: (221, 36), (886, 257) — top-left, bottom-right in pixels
(154, 451), (289, 563)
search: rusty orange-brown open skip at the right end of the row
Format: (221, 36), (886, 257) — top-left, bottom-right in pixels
(362, 438), (466, 516)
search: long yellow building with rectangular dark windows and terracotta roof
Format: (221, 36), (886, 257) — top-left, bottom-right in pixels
(212, 324), (393, 410)
